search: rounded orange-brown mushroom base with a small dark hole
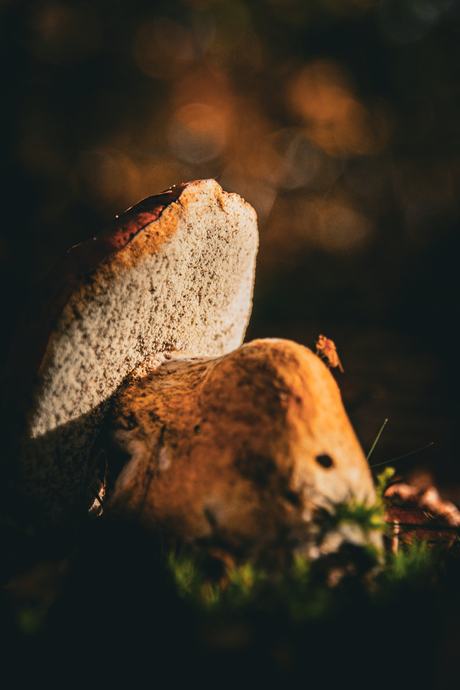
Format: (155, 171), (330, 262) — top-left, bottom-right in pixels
(106, 339), (381, 557)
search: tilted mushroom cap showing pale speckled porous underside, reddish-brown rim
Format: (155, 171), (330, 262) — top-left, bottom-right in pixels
(3, 180), (258, 531)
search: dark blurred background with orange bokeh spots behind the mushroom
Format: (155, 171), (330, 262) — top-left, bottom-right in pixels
(0, 0), (460, 490)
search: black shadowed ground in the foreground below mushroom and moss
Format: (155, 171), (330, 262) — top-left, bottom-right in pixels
(2, 523), (460, 689)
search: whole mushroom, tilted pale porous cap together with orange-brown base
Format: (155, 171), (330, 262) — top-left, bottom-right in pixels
(2, 180), (375, 553)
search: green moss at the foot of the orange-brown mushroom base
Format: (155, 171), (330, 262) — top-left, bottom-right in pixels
(163, 484), (452, 623)
